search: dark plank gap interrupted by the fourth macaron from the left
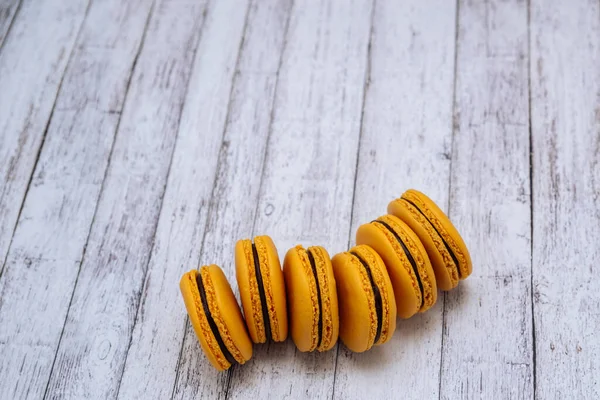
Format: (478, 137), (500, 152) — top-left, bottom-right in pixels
(331, 0), (377, 400)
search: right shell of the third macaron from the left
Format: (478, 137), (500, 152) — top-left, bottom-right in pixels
(309, 246), (340, 351)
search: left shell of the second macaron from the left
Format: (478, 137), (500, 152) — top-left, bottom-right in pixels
(235, 239), (266, 343)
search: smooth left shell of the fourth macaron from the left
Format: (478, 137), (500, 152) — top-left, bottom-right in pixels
(331, 253), (375, 353)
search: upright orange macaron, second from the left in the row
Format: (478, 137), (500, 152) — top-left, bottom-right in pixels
(235, 236), (288, 343)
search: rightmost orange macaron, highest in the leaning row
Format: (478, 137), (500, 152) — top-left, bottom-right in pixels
(388, 189), (473, 290)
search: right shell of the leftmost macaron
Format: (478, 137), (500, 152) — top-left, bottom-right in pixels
(203, 265), (252, 364)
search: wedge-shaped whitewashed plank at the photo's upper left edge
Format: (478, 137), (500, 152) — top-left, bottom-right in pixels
(0, 0), (88, 278)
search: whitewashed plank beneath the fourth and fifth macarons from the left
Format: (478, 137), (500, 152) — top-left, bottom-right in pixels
(334, 0), (456, 399)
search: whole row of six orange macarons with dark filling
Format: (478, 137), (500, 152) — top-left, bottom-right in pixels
(180, 190), (472, 370)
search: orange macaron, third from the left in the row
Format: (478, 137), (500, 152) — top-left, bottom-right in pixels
(283, 245), (340, 351)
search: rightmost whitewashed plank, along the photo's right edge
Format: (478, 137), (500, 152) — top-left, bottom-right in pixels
(530, 0), (600, 399)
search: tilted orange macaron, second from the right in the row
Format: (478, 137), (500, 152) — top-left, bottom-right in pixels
(356, 215), (437, 318)
